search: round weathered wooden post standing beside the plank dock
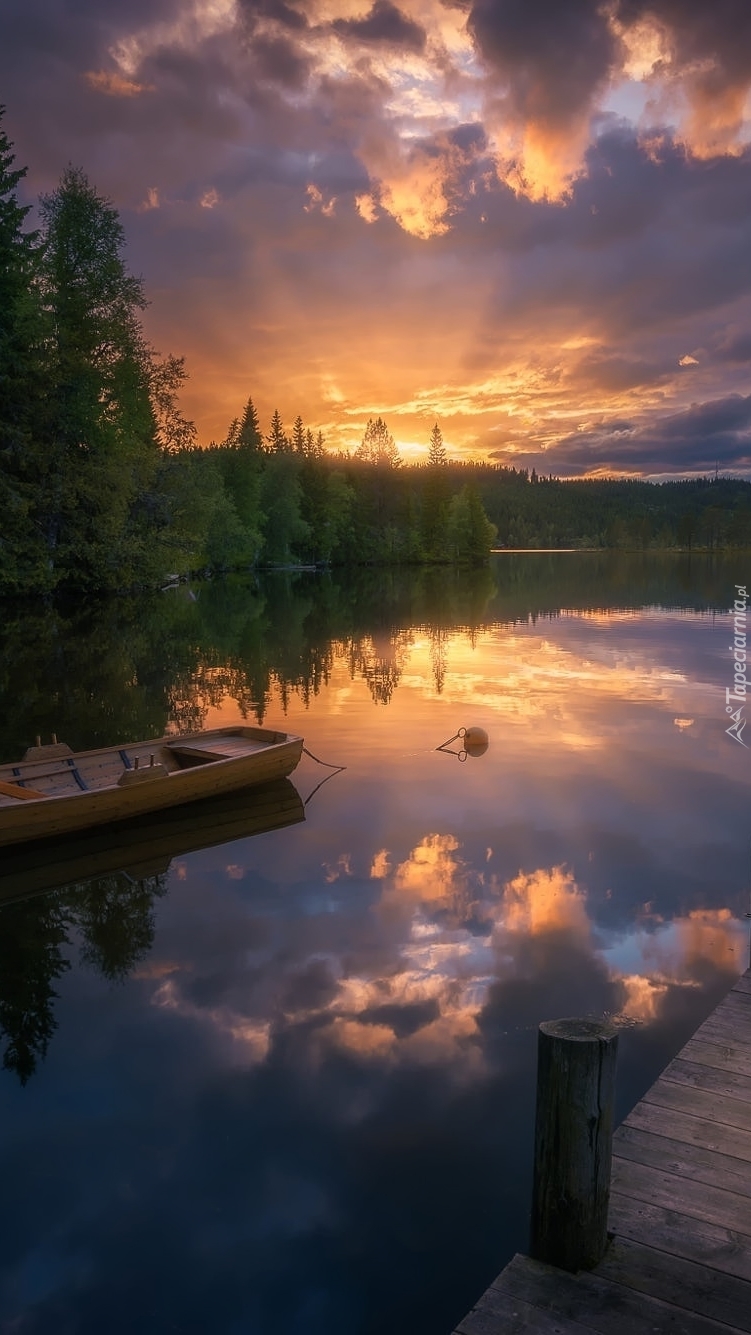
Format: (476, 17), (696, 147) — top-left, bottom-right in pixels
(530, 1019), (618, 1271)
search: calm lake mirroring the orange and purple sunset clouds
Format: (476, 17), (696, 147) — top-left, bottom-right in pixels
(0, 553), (751, 1335)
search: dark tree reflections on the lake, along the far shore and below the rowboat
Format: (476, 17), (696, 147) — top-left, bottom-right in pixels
(0, 551), (735, 1083)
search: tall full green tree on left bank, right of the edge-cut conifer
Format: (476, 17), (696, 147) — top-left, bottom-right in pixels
(41, 167), (160, 589)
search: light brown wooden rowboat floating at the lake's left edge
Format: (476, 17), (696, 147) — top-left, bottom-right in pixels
(0, 728), (303, 846)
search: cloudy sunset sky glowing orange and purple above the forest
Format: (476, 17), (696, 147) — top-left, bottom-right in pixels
(0, 0), (751, 478)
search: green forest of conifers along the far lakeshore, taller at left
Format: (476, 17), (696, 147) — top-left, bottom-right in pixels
(0, 108), (751, 597)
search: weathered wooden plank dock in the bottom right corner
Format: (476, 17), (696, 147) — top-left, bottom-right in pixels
(454, 969), (751, 1335)
